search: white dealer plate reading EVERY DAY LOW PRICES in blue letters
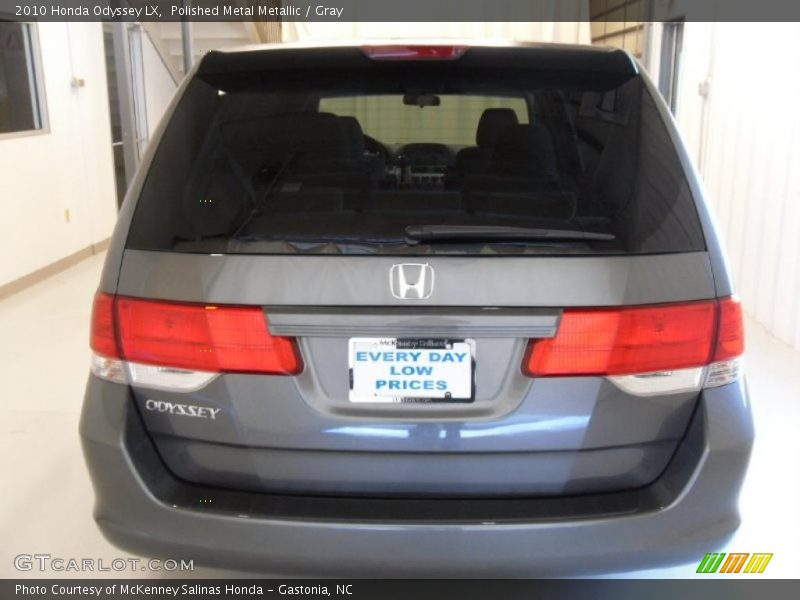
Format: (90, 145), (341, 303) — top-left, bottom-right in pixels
(349, 338), (475, 403)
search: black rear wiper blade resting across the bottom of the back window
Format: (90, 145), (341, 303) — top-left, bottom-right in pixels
(405, 225), (616, 245)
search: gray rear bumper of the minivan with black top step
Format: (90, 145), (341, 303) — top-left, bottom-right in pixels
(81, 377), (753, 577)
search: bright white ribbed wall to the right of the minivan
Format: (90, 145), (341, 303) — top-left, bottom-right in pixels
(664, 22), (800, 348)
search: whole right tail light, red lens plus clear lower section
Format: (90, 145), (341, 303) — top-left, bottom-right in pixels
(523, 298), (744, 392)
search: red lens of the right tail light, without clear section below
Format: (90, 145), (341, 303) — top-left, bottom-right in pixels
(523, 301), (720, 377)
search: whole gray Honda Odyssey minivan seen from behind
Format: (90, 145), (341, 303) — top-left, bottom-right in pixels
(81, 43), (753, 577)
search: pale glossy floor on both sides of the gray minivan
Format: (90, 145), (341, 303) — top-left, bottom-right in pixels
(0, 255), (800, 578)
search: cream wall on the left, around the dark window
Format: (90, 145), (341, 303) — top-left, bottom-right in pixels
(0, 23), (116, 286)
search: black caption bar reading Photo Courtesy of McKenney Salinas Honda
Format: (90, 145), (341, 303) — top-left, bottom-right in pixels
(0, 576), (800, 600)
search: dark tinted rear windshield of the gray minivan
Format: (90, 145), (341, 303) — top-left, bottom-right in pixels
(128, 54), (705, 255)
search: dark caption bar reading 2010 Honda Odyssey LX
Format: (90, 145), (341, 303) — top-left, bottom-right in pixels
(0, 0), (800, 22)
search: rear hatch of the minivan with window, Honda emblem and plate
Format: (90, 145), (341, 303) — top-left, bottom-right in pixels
(111, 45), (721, 497)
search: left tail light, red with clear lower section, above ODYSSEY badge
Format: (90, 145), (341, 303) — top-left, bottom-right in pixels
(91, 293), (303, 389)
